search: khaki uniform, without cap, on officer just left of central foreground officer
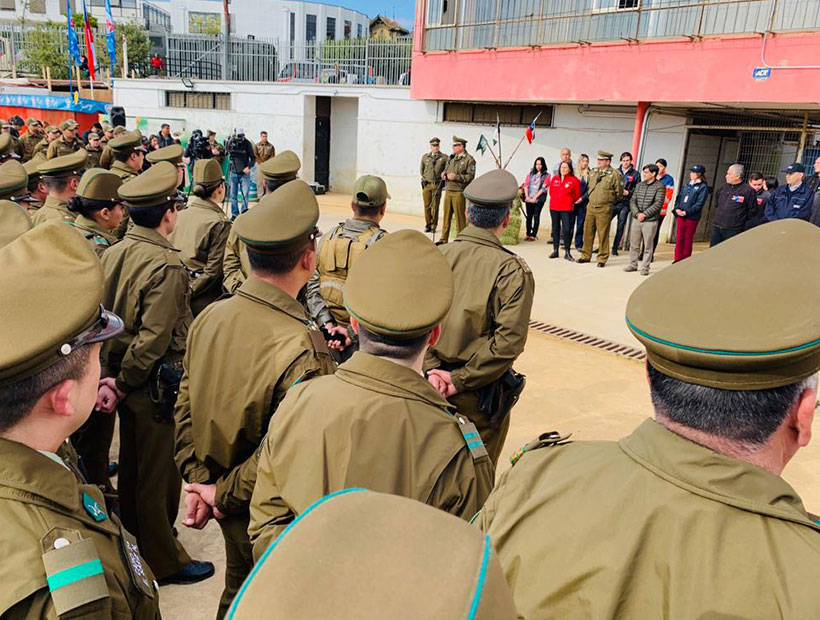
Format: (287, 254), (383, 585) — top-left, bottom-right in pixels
(175, 277), (335, 617)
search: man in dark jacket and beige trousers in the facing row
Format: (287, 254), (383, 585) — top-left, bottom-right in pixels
(624, 164), (666, 276)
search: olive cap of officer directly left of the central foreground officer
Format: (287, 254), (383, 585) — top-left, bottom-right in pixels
(233, 180), (319, 254)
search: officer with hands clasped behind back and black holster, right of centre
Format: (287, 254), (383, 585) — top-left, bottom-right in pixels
(425, 170), (535, 463)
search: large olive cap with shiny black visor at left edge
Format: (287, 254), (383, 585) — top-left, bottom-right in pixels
(0, 222), (122, 385)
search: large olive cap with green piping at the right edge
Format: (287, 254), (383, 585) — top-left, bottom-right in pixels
(626, 219), (820, 390)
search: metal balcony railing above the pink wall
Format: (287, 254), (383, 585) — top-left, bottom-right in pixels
(424, 0), (820, 51)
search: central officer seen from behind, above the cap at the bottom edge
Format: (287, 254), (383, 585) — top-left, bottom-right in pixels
(248, 230), (493, 558)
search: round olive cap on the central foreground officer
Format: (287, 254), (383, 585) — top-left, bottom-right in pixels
(344, 230), (454, 339)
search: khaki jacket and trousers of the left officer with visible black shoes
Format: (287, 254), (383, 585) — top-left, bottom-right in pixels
(102, 226), (191, 579)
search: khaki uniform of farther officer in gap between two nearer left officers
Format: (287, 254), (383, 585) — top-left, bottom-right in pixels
(168, 196), (231, 316)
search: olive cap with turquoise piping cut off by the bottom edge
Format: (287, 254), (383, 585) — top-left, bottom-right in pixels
(227, 488), (517, 620)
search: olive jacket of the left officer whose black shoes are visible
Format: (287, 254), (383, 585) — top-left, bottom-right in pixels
(102, 226), (191, 392)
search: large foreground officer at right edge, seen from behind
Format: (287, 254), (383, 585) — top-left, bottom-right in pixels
(478, 220), (820, 619)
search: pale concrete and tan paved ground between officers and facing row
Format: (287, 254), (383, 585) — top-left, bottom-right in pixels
(155, 195), (820, 620)
